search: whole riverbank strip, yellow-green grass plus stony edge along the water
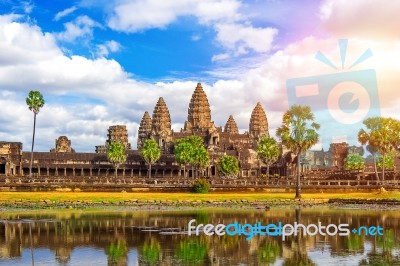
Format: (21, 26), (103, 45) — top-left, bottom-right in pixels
(0, 191), (400, 209)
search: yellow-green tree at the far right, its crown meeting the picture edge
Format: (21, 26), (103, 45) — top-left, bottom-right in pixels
(358, 117), (400, 180)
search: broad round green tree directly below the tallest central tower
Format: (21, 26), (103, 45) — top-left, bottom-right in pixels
(174, 136), (210, 178)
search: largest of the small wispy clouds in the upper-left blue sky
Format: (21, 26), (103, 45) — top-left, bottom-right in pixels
(56, 15), (101, 42)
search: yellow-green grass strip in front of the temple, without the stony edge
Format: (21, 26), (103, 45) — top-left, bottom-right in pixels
(0, 191), (400, 202)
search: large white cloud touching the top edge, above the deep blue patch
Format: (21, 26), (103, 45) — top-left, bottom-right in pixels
(108, 0), (278, 58)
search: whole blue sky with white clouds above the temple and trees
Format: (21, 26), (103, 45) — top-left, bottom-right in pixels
(0, 0), (400, 152)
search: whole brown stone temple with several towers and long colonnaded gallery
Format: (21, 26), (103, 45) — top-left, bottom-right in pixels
(0, 83), (354, 177)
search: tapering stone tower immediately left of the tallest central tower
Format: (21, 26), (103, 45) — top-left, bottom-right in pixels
(151, 97), (172, 151)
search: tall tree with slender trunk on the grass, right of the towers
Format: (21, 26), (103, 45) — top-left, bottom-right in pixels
(276, 105), (319, 198)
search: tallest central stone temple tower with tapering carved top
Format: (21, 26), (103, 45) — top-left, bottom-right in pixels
(183, 83), (214, 133)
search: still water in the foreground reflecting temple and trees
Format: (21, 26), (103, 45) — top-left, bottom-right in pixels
(0, 208), (400, 266)
